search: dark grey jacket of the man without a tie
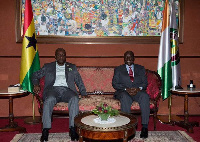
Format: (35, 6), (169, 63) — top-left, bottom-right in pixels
(32, 62), (86, 98)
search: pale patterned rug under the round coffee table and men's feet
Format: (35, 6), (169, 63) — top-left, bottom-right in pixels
(11, 131), (194, 142)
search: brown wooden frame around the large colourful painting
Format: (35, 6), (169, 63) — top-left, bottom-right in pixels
(15, 0), (185, 44)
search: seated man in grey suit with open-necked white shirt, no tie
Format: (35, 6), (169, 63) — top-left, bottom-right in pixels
(32, 48), (86, 141)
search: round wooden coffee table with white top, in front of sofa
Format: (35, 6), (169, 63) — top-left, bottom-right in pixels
(74, 112), (138, 142)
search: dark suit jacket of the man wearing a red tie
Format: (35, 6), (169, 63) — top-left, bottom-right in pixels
(112, 64), (148, 91)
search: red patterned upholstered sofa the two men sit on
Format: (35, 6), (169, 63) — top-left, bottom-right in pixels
(35, 67), (161, 130)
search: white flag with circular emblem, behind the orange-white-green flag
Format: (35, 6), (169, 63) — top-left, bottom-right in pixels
(170, 0), (181, 87)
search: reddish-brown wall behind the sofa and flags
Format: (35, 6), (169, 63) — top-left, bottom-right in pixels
(0, 0), (200, 117)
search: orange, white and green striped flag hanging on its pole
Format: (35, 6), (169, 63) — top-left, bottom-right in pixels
(158, 0), (172, 100)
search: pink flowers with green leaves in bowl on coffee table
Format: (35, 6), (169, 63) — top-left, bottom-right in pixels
(92, 103), (119, 121)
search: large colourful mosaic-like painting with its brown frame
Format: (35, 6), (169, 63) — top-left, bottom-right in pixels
(15, 0), (184, 44)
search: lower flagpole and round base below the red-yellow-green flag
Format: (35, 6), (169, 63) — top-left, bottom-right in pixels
(24, 95), (41, 124)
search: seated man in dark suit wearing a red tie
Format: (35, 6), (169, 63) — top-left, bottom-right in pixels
(112, 51), (150, 138)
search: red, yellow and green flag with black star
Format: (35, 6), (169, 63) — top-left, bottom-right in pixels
(20, 0), (40, 93)
